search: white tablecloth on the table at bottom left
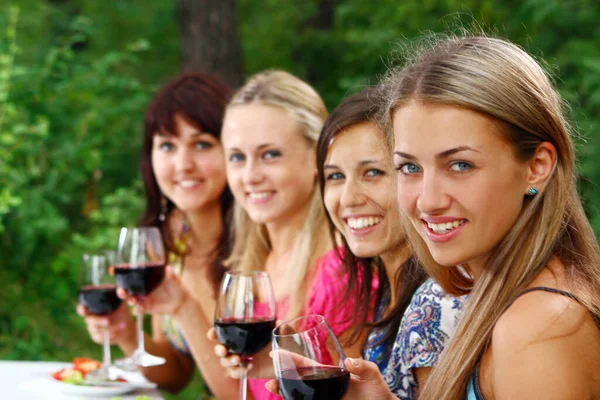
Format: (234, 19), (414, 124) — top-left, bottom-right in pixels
(0, 361), (164, 400)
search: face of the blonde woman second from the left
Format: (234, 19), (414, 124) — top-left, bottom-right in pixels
(221, 104), (317, 224)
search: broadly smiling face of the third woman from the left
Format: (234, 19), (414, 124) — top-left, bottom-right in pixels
(323, 122), (403, 257)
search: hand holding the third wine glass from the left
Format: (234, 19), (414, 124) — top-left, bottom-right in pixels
(206, 328), (275, 379)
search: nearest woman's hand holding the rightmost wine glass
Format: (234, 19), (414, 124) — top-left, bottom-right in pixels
(265, 358), (396, 400)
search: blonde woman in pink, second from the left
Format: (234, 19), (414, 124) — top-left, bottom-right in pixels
(210, 71), (364, 399)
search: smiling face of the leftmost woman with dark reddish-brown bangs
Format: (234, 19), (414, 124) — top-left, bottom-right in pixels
(152, 115), (227, 212)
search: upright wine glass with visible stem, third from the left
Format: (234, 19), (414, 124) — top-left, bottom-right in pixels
(214, 271), (275, 400)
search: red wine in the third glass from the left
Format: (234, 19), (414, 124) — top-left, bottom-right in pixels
(215, 318), (275, 357)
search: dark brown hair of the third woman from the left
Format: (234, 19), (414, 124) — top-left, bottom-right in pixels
(317, 88), (427, 344)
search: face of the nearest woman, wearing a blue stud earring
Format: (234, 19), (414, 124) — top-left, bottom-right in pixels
(393, 102), (528, 273)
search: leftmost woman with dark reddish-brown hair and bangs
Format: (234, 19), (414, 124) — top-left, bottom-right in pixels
(78, 73), (233, 392)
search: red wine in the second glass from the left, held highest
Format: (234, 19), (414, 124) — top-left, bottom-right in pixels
(114, 264), (165, 297)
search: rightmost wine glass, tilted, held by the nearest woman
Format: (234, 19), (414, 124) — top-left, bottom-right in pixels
(273, 314), (350, 400)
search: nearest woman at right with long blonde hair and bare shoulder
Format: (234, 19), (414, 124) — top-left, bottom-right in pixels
(360, 37), (600, 400)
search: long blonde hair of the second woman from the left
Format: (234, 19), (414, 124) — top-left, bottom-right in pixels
(227, 71), (329, 318)
